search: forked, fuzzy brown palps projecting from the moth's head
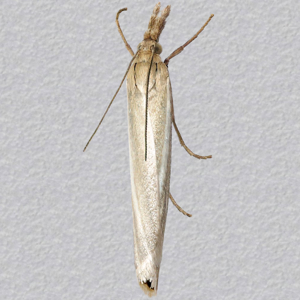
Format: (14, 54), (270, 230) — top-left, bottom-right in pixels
(144, 2), (171, 43)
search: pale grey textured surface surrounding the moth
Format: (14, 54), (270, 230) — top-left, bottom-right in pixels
(0, 0), (300, 300)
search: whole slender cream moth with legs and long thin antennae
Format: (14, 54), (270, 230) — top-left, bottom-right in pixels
(84, 3), (213, 297)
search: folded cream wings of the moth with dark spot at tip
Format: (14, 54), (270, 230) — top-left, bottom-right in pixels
(127, 55), (172, 296)
